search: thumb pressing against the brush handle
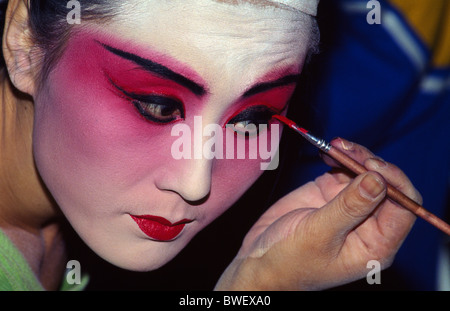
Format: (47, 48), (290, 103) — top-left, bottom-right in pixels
(315, 172), (386, 241)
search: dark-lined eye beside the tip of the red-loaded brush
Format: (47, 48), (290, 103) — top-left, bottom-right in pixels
(226, 106), (276, 137)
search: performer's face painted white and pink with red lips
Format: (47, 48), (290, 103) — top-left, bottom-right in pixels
(34, 0), (308, 271)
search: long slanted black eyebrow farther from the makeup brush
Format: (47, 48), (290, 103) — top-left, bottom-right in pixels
(99, 42), (206, 96)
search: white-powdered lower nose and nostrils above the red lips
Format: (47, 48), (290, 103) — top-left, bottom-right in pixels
(157, 159), (213, 205)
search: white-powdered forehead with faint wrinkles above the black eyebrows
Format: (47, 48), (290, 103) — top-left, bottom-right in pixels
(98, 0), (309, 90)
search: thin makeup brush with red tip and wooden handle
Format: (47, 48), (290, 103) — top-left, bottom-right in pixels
(273, 115), (450, 236)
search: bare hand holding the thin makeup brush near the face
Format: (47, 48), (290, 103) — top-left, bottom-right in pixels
(216, 139), (422, 290)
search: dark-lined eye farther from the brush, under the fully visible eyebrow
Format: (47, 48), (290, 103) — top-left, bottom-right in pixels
(132, 95), (185, 124)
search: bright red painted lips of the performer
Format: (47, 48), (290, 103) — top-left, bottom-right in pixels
(131, 215), (191, 241)
